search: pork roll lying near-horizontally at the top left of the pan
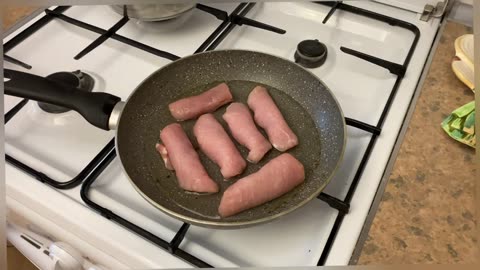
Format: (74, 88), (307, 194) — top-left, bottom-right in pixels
(168, 83), (233, 121)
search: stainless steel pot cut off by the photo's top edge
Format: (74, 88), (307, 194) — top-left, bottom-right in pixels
(111, 3), (196, 21)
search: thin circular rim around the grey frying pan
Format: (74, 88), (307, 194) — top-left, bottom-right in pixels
(115, 49), (347, 229)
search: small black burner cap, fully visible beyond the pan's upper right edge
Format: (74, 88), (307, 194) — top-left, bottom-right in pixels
(295, 39), (327, 68)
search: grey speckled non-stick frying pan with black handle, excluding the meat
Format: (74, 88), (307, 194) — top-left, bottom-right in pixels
(4, 50), (346, 229)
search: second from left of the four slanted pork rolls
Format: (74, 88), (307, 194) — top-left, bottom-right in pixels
(193, 113), (247, 179)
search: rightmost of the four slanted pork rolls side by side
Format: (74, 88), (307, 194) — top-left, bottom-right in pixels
(247, 86), (298, 152)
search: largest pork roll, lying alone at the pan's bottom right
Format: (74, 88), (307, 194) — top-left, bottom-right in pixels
(218, 153), (305, 218)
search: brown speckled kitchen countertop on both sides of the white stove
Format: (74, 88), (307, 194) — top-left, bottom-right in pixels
(2, 7), (477, 264)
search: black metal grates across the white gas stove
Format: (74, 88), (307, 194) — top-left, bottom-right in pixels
(4, 1), (420, 268)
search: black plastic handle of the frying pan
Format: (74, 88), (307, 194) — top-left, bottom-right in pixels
(4, 69), (121, 130)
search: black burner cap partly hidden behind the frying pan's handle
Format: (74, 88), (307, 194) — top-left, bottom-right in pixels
(38, 70), (95, 113)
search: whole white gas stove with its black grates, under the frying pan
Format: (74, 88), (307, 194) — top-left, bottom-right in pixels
(4, 1), (442, 269)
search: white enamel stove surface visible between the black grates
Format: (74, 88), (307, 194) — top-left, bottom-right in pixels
(4, 1), (439, 268)
